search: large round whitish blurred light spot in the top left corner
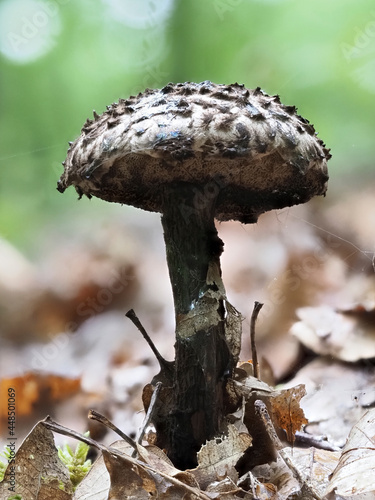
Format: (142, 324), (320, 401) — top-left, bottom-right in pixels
(0, 0), (61, 64)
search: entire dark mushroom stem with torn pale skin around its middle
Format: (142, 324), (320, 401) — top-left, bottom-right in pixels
(160, 183), (237, 470)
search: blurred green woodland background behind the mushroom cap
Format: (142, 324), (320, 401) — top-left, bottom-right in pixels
(0, 0), (375, 250)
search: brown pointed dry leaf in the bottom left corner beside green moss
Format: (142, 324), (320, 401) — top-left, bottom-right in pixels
(0, 423), (73, 500)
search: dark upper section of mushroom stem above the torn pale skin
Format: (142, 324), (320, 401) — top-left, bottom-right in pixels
(162, 183), (225, 316)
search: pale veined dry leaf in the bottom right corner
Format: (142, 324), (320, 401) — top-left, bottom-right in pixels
(326, 409), (375, 500)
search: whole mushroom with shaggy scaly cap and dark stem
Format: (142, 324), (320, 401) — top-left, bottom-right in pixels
(58, 81), (330, 468)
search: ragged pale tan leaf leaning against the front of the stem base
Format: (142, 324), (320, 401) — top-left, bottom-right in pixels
(190, 425), (252, 489)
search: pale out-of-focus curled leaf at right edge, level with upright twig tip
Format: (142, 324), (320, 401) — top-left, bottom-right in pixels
(291, 306), (375, 362)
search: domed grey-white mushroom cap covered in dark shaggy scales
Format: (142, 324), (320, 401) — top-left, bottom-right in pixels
(58, 81), (331, 223)
